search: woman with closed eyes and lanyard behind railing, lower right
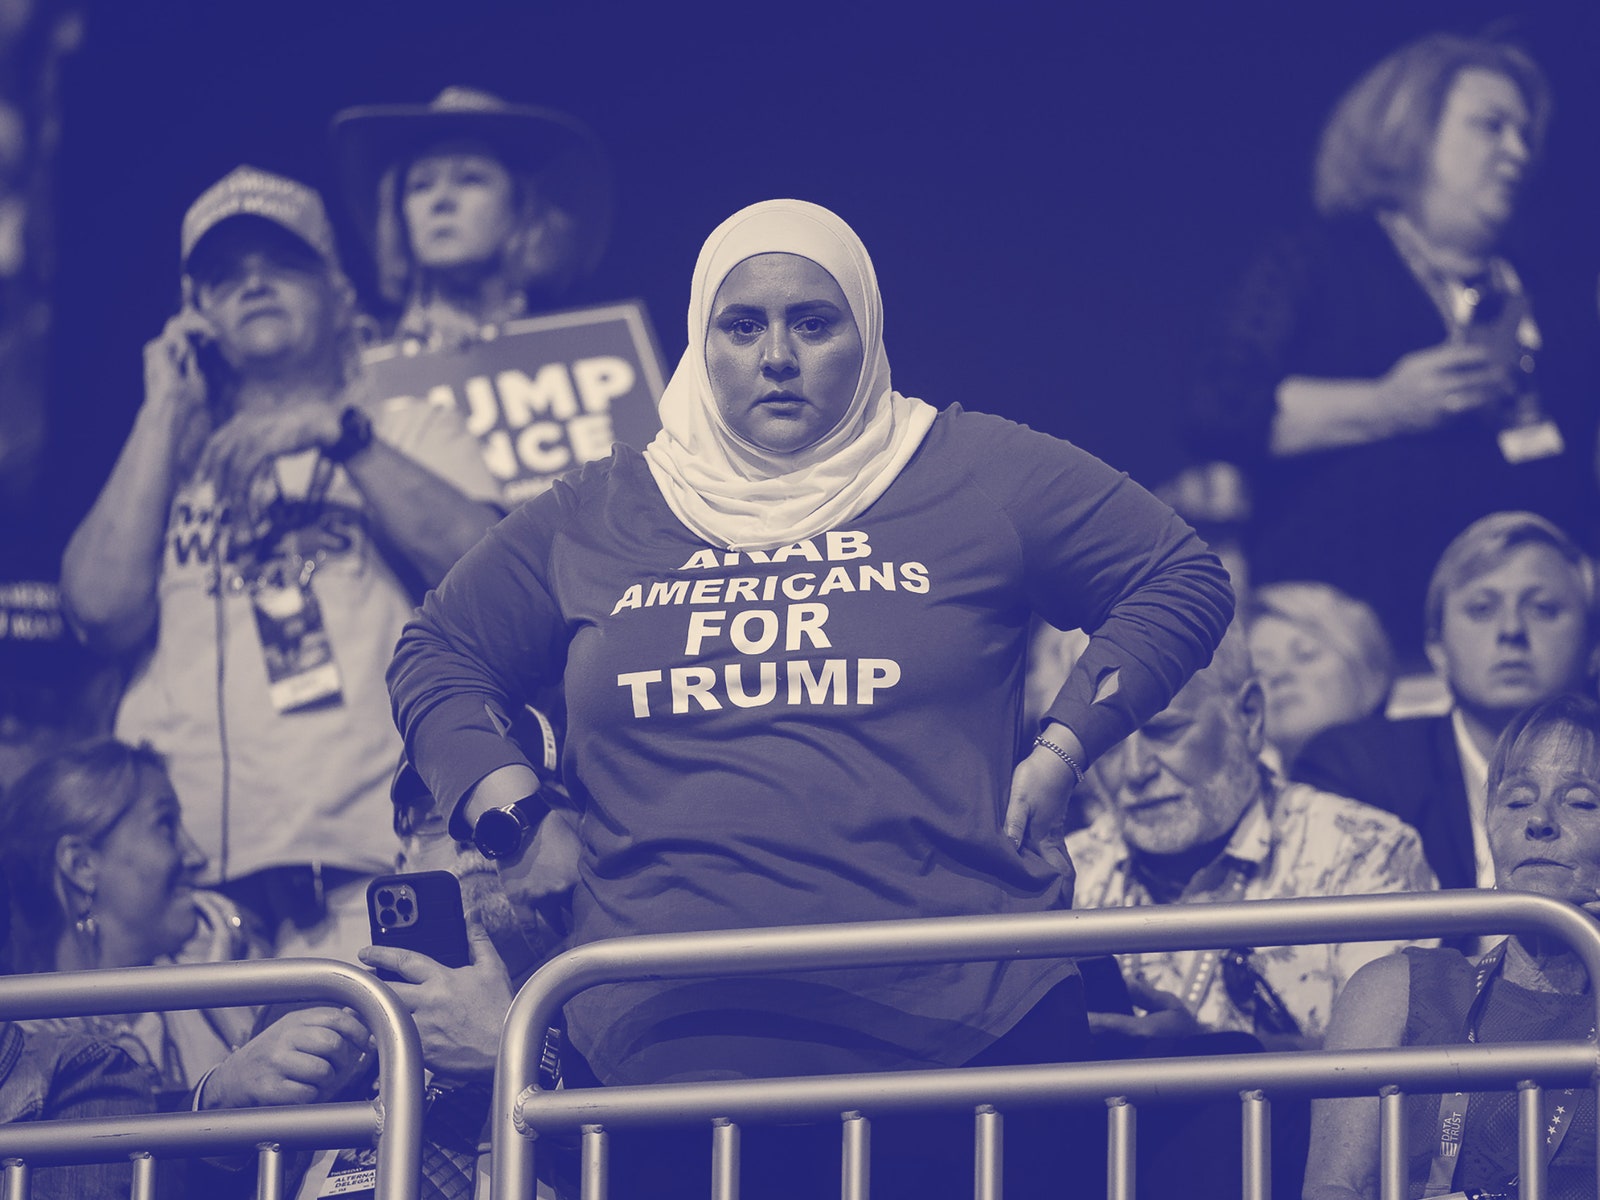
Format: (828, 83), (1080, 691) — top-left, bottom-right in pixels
(1306, 696), (1600, 1200)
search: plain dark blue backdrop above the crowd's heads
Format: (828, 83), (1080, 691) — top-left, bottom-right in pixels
(11, 0), (1600, 569)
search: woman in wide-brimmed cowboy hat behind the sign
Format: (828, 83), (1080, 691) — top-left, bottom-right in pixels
(333, 88), (611, 349)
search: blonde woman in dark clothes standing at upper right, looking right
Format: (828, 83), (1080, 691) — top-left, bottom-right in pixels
(1190, 34), (1600, 670)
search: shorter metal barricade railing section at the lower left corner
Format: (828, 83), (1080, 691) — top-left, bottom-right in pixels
(0, 958), (422, 1200)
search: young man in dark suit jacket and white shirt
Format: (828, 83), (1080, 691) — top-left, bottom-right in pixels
(1293, 512), (1597, 888)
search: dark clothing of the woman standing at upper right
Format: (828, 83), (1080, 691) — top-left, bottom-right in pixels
(1189, 218), (1595, 658)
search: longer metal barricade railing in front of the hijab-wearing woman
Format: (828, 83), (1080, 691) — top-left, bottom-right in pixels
(491, 891), (1600, 1200)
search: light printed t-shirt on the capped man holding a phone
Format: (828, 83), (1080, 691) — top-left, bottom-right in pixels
(117, 398), (498, 882)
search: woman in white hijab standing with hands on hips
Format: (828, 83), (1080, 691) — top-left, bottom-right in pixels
(389, 200), (1232, 1196)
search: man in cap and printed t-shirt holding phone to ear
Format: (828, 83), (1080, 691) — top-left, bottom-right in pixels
(62, 166), (498, 958)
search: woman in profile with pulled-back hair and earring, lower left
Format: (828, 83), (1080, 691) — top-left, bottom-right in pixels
(0, 739), (368, 1126)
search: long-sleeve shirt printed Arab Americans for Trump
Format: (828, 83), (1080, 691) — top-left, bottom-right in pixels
(390, 408), (1232, 1082)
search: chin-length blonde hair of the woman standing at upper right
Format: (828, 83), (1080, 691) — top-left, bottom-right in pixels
(1312, 34), (1550, 216)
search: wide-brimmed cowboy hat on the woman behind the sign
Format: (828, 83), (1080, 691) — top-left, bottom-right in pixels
(331, 88), (611, 275)
